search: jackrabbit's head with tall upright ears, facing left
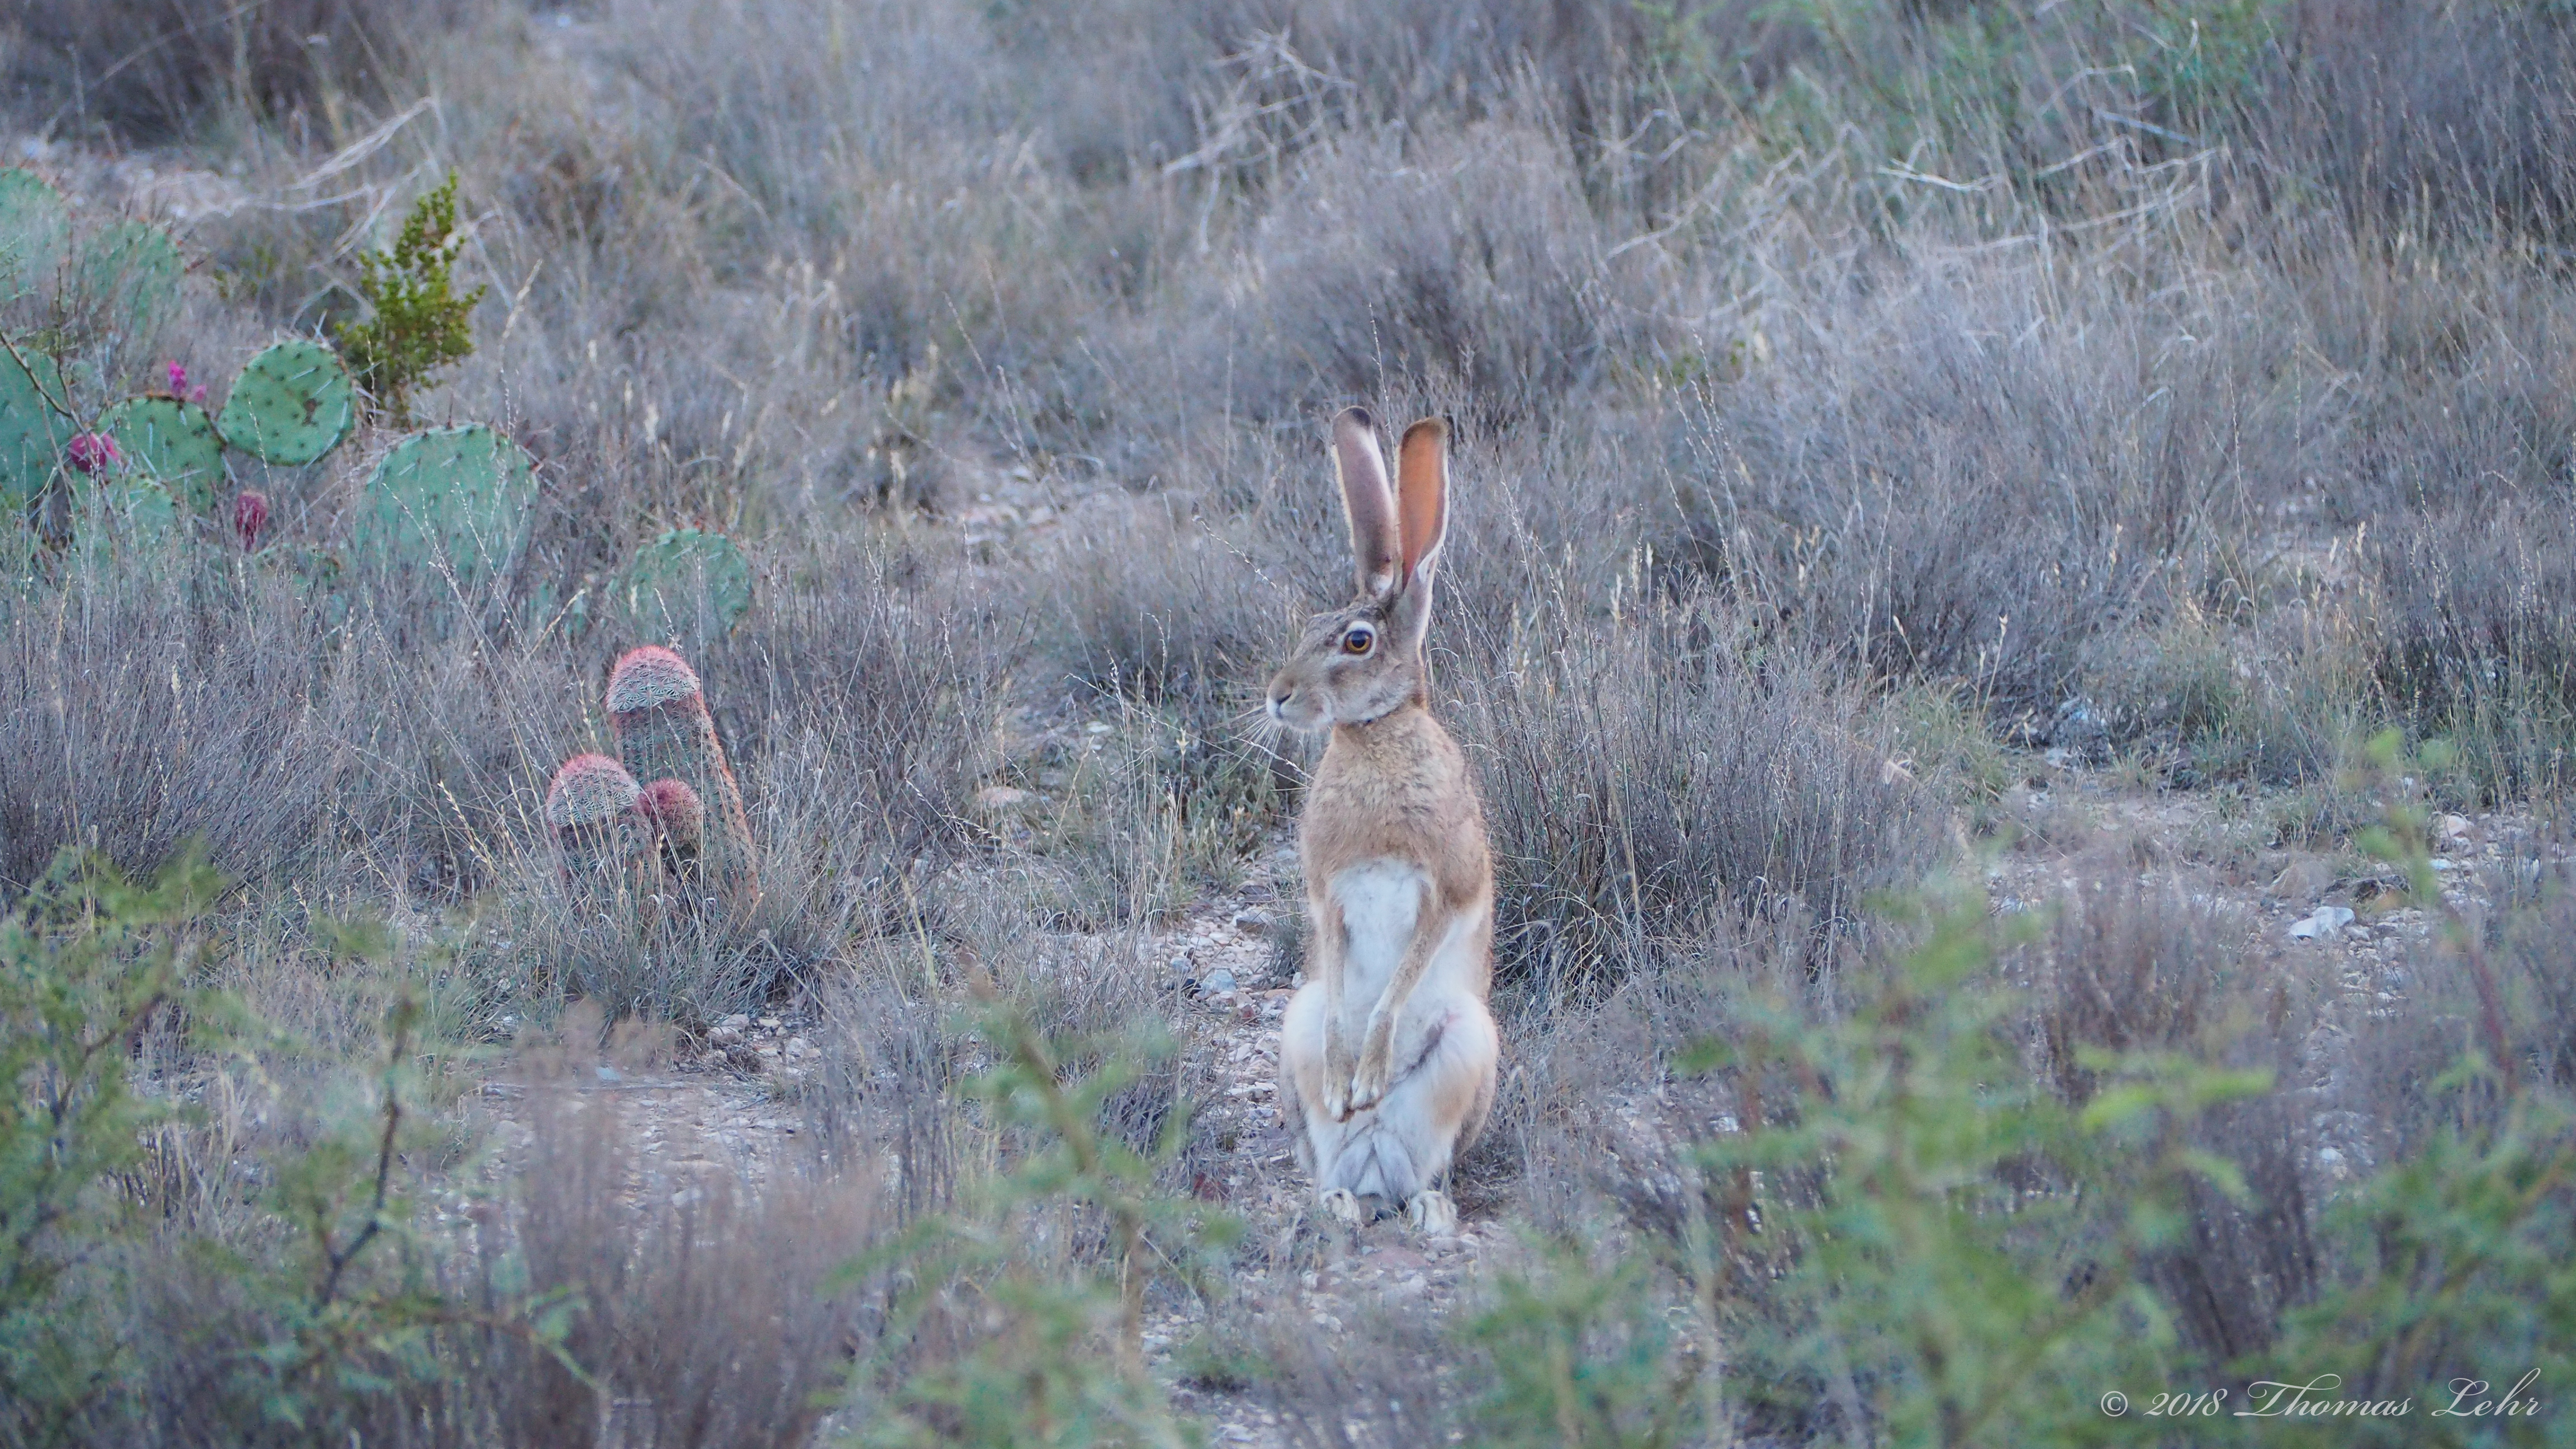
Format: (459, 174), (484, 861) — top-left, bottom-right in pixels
(1270, 408), (1448, 730)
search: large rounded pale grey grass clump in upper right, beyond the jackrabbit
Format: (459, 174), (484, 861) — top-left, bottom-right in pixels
(1674, 261), (2270, 719)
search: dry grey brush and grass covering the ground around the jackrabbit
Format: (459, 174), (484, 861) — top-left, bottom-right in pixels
(0, 0), (2576, 1444)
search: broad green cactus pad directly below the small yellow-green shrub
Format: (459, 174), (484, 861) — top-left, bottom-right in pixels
(358, 423), (536, 583)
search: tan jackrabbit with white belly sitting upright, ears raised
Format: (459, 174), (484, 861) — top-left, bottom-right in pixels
(1270, 408), (1499, 1233)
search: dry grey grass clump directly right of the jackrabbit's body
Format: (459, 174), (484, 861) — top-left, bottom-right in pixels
(1453, 598), (1940, 1003)
